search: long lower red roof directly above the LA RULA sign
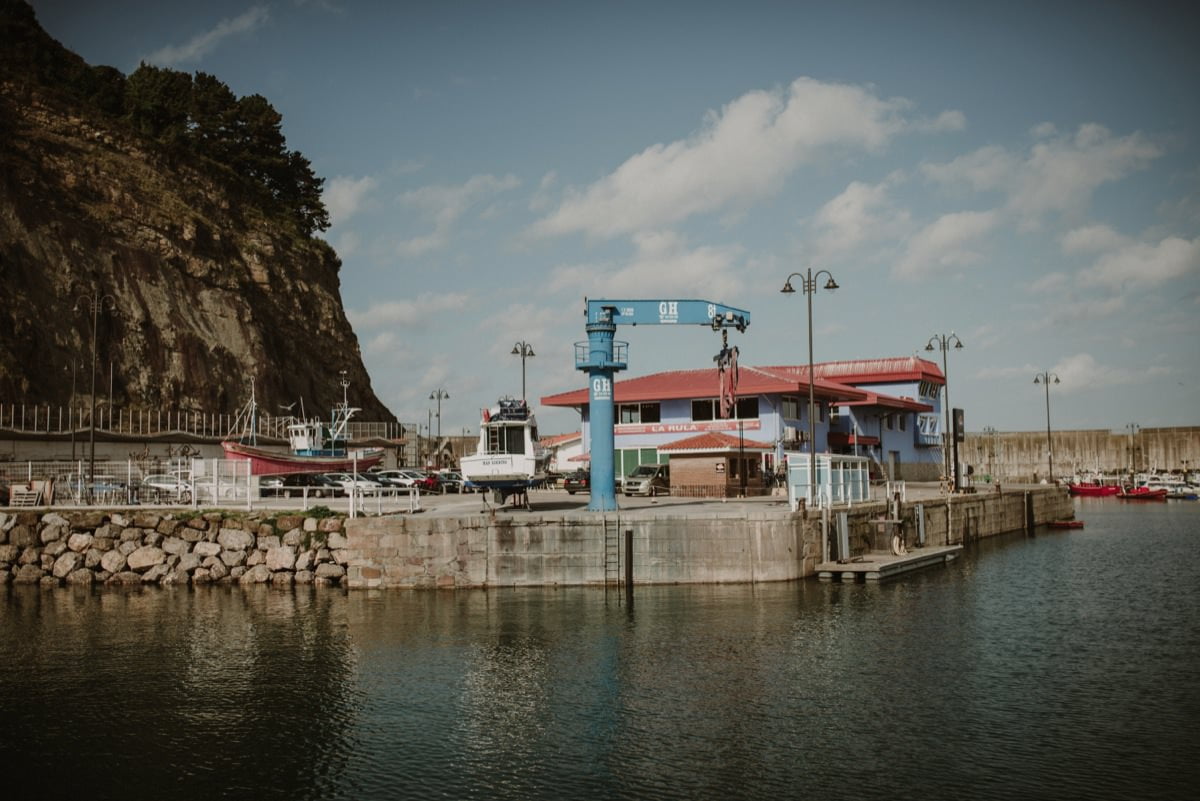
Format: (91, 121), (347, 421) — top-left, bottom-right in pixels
(541, 367), (868, 406)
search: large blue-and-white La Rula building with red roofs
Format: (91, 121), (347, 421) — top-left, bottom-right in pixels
(541, 356), (946, 481)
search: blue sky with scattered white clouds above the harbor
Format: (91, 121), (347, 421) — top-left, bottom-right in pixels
(32, 0), (1200, 434)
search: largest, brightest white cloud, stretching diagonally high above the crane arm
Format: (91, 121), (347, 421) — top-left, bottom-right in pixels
(530, 78), (960, 237)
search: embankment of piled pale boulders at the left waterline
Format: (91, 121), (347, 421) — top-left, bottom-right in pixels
(0, 511), (347, 586)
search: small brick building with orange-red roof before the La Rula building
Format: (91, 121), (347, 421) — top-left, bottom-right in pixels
(659, 432), (774, 498)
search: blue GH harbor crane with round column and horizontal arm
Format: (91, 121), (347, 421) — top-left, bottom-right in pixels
(575, 300), (750, 512)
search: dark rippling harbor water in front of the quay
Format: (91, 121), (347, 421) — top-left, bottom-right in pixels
(0, 499), (1200, 800)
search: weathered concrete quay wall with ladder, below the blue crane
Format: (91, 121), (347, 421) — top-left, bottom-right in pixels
(344, 484), (1074, 589)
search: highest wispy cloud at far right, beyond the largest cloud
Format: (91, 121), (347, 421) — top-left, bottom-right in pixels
(922, 124), (1162, 225)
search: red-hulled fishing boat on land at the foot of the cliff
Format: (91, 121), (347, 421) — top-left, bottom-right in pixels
(221, 380), (383, 476)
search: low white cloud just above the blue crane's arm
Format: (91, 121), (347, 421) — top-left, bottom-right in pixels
(548, 231), (746, 297)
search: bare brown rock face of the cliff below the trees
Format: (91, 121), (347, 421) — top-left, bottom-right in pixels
(0, 0), (395, 421)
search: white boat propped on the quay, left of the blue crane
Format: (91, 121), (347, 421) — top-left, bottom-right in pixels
(460, 398), (550, 505)
